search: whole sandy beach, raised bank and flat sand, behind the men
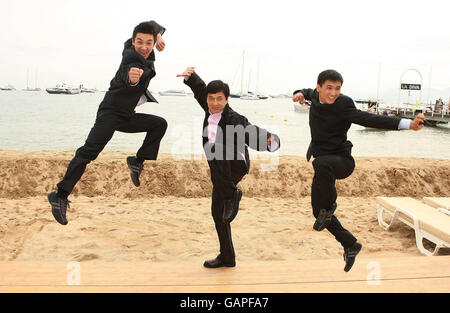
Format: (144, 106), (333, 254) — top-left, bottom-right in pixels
(0, 150), (450, 264)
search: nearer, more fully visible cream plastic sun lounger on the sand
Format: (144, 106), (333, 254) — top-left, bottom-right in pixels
(377, 197), (450, 256)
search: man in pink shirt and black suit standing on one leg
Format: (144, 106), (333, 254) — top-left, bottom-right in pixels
(177, 67), (280, 268)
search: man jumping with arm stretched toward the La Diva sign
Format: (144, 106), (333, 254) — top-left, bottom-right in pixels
(293, 70), (425, 272)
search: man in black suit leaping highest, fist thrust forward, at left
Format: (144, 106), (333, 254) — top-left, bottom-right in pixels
(48, 21), (167, 225)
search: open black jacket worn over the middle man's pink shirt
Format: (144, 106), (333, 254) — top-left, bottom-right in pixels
(184, 73), (280, 173)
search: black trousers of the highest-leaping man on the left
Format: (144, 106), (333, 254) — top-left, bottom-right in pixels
(57, 112), (167, 194)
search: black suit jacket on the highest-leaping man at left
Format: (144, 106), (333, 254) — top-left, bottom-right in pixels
(98, 21), (165, 117)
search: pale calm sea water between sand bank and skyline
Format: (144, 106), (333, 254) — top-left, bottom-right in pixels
(0, 91), (450, 159)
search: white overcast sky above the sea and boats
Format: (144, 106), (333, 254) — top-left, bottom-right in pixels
(0, 0), (450, 99)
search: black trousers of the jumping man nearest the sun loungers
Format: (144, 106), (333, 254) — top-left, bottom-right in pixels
(311, 155), (356, 248)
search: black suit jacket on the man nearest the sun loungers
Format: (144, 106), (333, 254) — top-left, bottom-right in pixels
(294, 89), (400, 161)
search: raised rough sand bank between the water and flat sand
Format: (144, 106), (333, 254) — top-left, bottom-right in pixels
(0, 150), (450, 199)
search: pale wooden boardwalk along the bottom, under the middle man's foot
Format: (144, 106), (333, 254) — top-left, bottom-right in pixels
(0, 256), (450, 293)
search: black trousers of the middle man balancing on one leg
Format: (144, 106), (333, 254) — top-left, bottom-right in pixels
(208, 160), (246, 260)
